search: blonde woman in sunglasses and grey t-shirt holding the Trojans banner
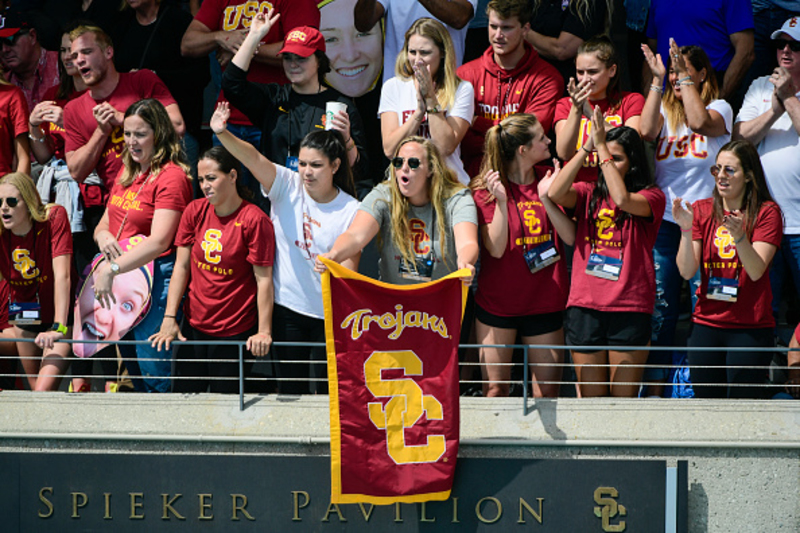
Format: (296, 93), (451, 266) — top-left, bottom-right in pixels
(317, 137), (478, 285)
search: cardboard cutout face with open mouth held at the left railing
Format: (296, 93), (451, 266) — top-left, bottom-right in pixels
(72, 235), (153, 357)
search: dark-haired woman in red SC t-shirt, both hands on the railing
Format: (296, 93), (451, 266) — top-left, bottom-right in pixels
(150, 146), (275, 393)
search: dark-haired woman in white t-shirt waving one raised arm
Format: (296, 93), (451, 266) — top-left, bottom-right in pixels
(211, 103), (358, 394)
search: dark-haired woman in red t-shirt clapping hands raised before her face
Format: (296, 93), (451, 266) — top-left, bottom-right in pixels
(549, 107), (665, 396)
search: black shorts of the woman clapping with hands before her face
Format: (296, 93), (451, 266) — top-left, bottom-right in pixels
(564, 307), (652, 351)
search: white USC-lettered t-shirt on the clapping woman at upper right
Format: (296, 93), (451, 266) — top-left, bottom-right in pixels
(656, 100), (733, 223)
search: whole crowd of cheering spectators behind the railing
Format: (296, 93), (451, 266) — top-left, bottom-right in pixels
(0, 0), (800, 398)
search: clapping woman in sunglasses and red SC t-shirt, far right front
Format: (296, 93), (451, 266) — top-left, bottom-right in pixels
(672, 141), (783, 398)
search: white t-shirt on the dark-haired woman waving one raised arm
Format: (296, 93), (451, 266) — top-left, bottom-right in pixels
(261, 165), (358, 318)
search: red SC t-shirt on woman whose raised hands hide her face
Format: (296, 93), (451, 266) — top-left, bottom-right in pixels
(568, 183), (666, 314)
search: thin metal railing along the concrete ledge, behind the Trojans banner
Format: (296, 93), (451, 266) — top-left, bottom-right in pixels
(0, 339), (800, 412)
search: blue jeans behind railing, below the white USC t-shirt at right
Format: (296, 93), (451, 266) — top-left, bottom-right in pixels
(645, 220), (700, 382)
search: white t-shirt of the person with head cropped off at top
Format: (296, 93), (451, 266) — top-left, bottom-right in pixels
(378, 0), (478, 83)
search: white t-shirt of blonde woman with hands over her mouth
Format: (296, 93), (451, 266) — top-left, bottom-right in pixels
(378, 77), (475, 185)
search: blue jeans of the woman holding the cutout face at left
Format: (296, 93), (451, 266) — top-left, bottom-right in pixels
(119, 254), (183, 392)
